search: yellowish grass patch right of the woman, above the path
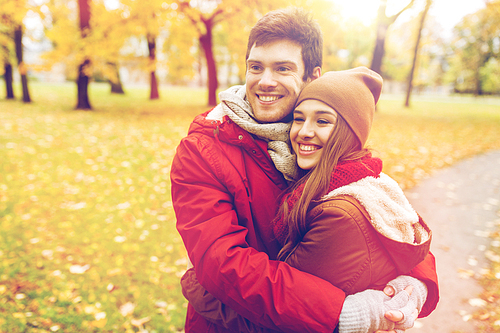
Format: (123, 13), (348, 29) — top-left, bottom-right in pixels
(374, 96), (500, 189)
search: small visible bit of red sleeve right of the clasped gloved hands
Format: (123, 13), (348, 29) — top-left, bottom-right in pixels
(409, 252), (439, 318)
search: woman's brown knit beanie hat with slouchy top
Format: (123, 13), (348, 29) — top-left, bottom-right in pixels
(295, 67), (383, 148)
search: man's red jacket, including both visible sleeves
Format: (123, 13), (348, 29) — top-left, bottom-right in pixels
(171, 112), (439, 333)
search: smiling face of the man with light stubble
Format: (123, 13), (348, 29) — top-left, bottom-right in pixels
(246, 40), (310, 123)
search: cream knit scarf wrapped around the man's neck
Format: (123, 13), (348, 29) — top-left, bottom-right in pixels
(207, 85), (298, 181)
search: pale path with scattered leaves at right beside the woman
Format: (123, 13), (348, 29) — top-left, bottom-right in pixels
(407, 151), (500, 333)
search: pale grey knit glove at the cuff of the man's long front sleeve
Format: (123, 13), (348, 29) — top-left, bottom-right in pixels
(339, 289), (415, 333)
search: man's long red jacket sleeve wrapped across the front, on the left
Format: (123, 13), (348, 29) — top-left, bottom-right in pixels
(171, 137), (345, 333)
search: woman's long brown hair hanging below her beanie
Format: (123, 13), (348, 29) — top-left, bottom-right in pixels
(278, 114), (369, 261)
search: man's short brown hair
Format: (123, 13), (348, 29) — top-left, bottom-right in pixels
(245, 7), (323, 81)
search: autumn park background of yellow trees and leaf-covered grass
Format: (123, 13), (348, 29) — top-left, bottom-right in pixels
(0, 0), (500, 333)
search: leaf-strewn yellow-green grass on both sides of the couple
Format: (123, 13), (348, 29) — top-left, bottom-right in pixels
(0, 83), (500, 332)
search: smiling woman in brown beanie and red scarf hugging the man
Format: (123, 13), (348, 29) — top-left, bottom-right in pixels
(182, 67), (431, 332)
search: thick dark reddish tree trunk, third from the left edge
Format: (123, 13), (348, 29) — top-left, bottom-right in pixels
(76, 0), (92, 110)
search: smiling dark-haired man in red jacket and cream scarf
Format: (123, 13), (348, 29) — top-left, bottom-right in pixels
(171, 9), (438, 332)
